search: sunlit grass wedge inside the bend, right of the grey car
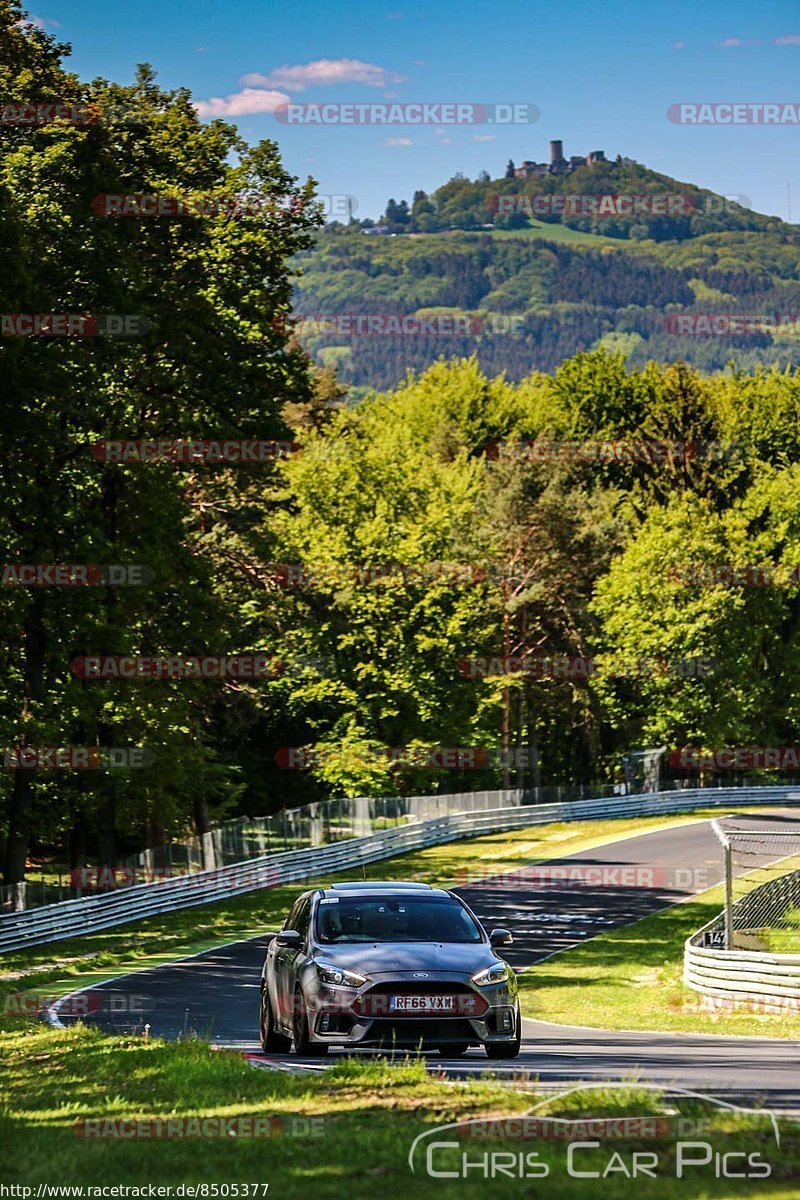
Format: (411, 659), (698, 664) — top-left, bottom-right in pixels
(519, 886), (800, 1038)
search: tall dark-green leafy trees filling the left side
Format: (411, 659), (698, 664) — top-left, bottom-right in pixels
(0, 4), (315, 883)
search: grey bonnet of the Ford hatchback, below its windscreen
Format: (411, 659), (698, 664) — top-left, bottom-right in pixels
(314, 942), (498, 976)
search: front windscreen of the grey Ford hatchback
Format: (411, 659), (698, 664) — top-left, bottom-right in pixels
(317, 895), (481, 942)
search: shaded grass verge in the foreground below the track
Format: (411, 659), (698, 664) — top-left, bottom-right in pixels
(0, 1026), (800, 1200)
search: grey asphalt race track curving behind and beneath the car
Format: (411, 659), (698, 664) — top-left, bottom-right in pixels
(54, 810), (800, 1110)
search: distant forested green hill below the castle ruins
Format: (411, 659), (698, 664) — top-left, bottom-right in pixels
(295, 162), (800, 389)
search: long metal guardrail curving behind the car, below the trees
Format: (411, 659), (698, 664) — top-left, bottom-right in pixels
(0, 786), (800, 954)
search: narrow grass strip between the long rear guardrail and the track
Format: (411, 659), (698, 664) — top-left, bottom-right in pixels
(0, 810), (714, 1013)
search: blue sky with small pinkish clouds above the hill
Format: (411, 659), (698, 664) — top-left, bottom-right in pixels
(31, 0), (800, 221)
